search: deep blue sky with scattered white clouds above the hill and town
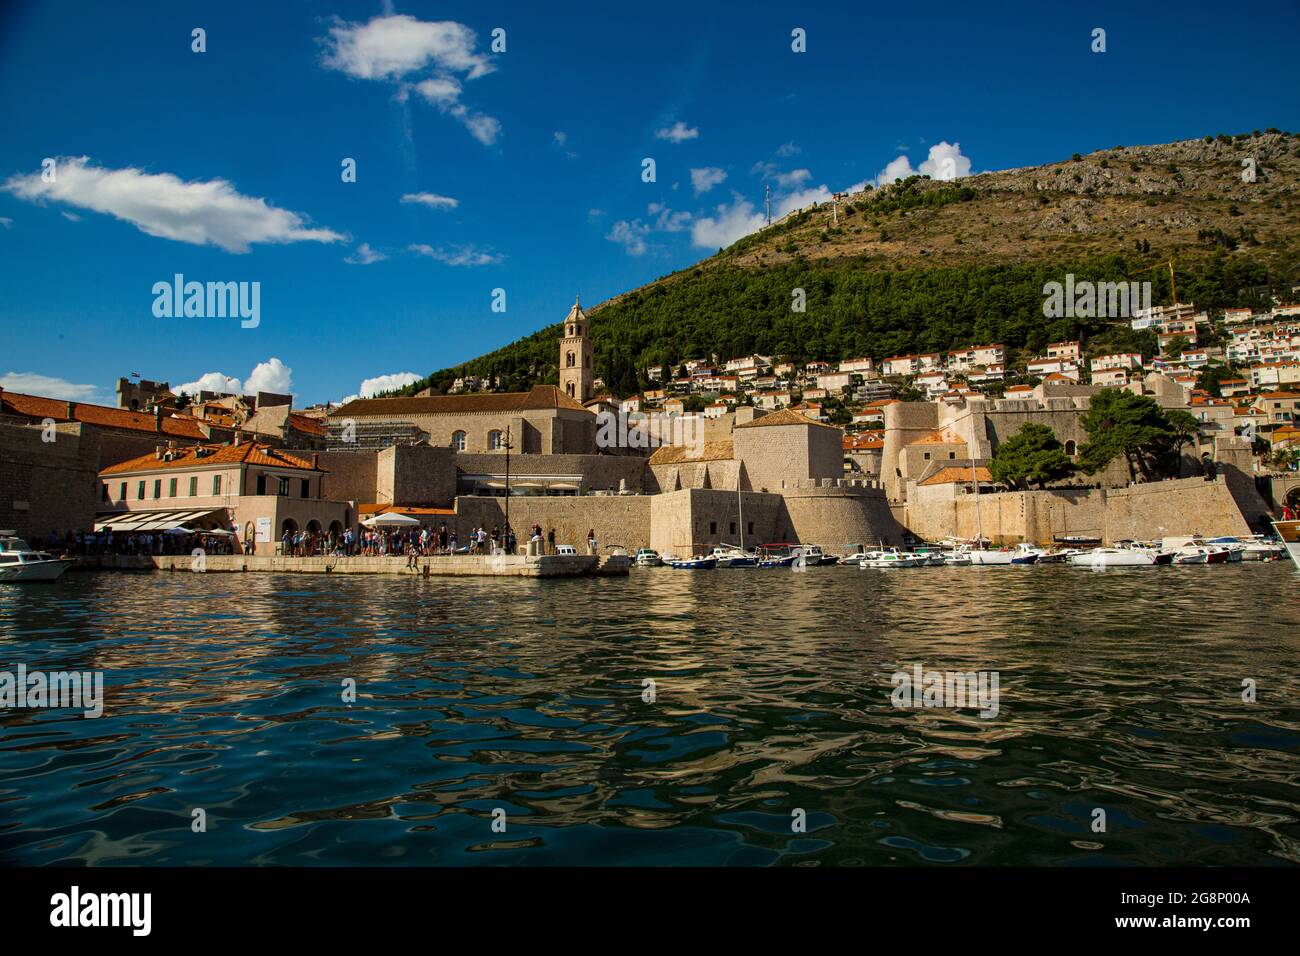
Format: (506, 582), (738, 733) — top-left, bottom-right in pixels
(0, 0), (1300, 405)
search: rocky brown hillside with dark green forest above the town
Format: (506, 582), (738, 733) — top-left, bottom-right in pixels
(408, 130), (1300, 393)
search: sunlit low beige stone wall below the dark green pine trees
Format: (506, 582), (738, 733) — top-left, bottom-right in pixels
(905, 473), (1255, 544)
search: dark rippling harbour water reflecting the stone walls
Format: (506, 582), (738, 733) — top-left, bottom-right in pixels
(0, 563), (1300, 865)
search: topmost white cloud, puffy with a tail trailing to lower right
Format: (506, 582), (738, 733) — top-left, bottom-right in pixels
(322, 14), (501, 146)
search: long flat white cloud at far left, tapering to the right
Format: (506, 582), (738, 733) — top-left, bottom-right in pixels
(0, 156), (345, 252)
